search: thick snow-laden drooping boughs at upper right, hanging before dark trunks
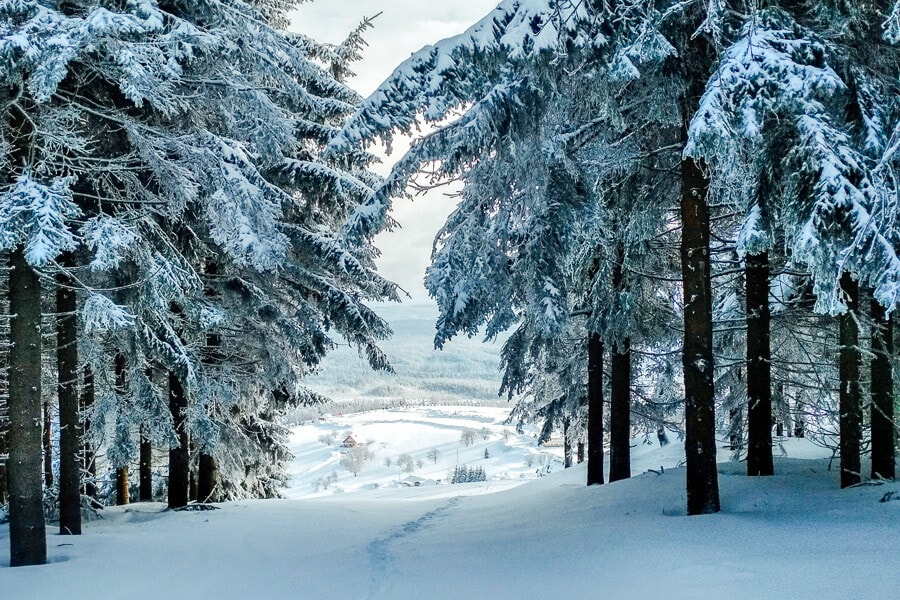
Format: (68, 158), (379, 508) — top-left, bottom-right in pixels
(684, 10), (900, 313)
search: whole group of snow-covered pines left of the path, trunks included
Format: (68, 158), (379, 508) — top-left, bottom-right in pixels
(0, 0), (397, 566)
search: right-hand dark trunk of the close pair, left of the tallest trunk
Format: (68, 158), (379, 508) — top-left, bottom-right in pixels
(609, 338), (631, 482)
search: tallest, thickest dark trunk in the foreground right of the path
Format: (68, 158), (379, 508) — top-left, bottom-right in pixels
(681, 152), (719, 515)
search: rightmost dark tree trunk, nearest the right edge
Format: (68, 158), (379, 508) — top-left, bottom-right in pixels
(871, 299), (896, 479)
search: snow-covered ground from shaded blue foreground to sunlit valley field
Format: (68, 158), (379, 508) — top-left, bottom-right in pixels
(0, 407), (900, 600)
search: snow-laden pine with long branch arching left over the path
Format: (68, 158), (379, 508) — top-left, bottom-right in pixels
(332, 2), (669, 490)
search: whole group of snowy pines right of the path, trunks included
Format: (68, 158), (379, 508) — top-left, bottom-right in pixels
(329, 0), (900, 514)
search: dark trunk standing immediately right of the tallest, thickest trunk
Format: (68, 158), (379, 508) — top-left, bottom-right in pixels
(746, 252), (775, 476)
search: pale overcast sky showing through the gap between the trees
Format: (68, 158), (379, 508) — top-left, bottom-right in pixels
(293, 0), (499, 303)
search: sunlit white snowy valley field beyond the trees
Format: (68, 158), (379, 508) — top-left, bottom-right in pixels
(285, 405), (684, 498)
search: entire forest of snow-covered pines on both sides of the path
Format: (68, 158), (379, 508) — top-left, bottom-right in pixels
(0, 0), (900, 566)
